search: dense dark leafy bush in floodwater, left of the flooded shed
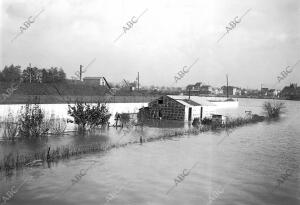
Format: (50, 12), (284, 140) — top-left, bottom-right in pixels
(68, 101), (111, 130)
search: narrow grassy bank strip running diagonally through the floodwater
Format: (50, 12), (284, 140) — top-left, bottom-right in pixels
(0, 115), (265, 174)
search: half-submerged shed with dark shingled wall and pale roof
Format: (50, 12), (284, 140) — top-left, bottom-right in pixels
(145, 95), (216, 121)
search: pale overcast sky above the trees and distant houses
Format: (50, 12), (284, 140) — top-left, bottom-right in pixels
(0, 0), (300, 88)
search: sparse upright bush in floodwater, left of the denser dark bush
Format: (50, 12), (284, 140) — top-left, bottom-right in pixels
(19, 104), (50, 138)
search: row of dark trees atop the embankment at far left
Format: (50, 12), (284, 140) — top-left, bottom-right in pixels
(0, 64), (66, 83)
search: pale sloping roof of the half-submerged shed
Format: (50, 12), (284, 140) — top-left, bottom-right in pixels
(167, 95), (216, 106)
